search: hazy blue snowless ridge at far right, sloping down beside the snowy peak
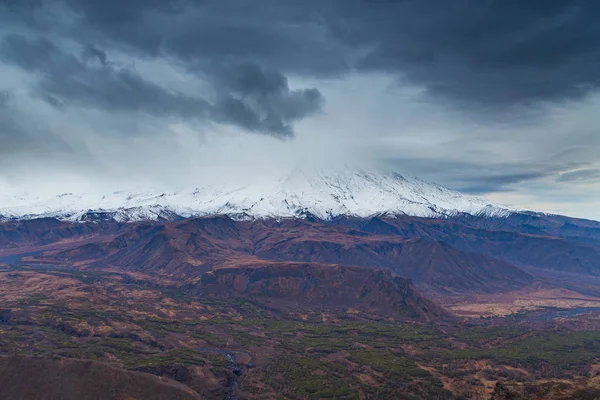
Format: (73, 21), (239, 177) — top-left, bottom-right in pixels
(333, 213), (600, 275)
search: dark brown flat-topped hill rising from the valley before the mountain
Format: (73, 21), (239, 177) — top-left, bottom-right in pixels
(196, 262), (448, 320)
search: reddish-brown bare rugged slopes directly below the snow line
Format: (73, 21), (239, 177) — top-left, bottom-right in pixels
(0, 216), (533, 293)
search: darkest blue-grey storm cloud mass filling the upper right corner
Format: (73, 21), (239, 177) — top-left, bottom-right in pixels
(338, 0), (600, 106)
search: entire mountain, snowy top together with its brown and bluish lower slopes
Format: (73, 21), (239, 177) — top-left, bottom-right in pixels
(0, 164), (600, 301)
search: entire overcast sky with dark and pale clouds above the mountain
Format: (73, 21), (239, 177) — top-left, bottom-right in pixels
(0, 0), (600, 219)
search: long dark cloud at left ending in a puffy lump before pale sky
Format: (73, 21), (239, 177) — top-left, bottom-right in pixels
(0, 35), (322, 137)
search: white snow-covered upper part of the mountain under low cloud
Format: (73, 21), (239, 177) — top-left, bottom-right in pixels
(0, 167), (511, 221)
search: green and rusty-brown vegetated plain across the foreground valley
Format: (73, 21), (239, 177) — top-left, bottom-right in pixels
(5, 267), (600, 399)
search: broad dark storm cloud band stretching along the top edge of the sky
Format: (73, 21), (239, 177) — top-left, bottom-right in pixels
(5, 0), (600, 107)
